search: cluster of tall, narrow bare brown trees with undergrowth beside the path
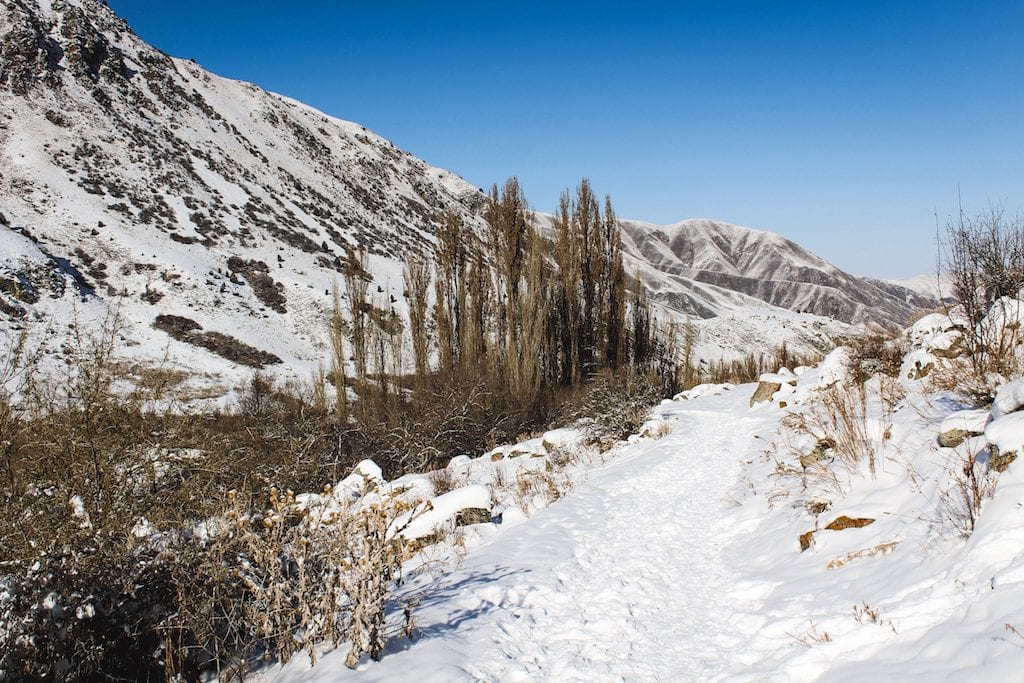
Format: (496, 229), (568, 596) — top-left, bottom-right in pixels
(326, 178), (676, 473)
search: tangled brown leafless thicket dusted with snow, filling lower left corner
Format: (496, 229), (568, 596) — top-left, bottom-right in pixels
(0, 324), (419, 681)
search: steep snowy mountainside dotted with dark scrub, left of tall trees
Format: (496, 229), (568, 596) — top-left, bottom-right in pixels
(0, 0), (482, 387)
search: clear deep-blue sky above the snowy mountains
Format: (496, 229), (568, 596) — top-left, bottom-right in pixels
(110, 0), (1024, 278)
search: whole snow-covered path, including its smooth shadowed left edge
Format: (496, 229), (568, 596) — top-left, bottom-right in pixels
(281, 395), (760, 681)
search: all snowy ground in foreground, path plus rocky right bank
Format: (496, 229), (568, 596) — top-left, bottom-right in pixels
(262, 344), (1024, 683)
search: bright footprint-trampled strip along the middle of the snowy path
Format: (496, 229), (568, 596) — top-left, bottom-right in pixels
(465, 411), (765, 681)
